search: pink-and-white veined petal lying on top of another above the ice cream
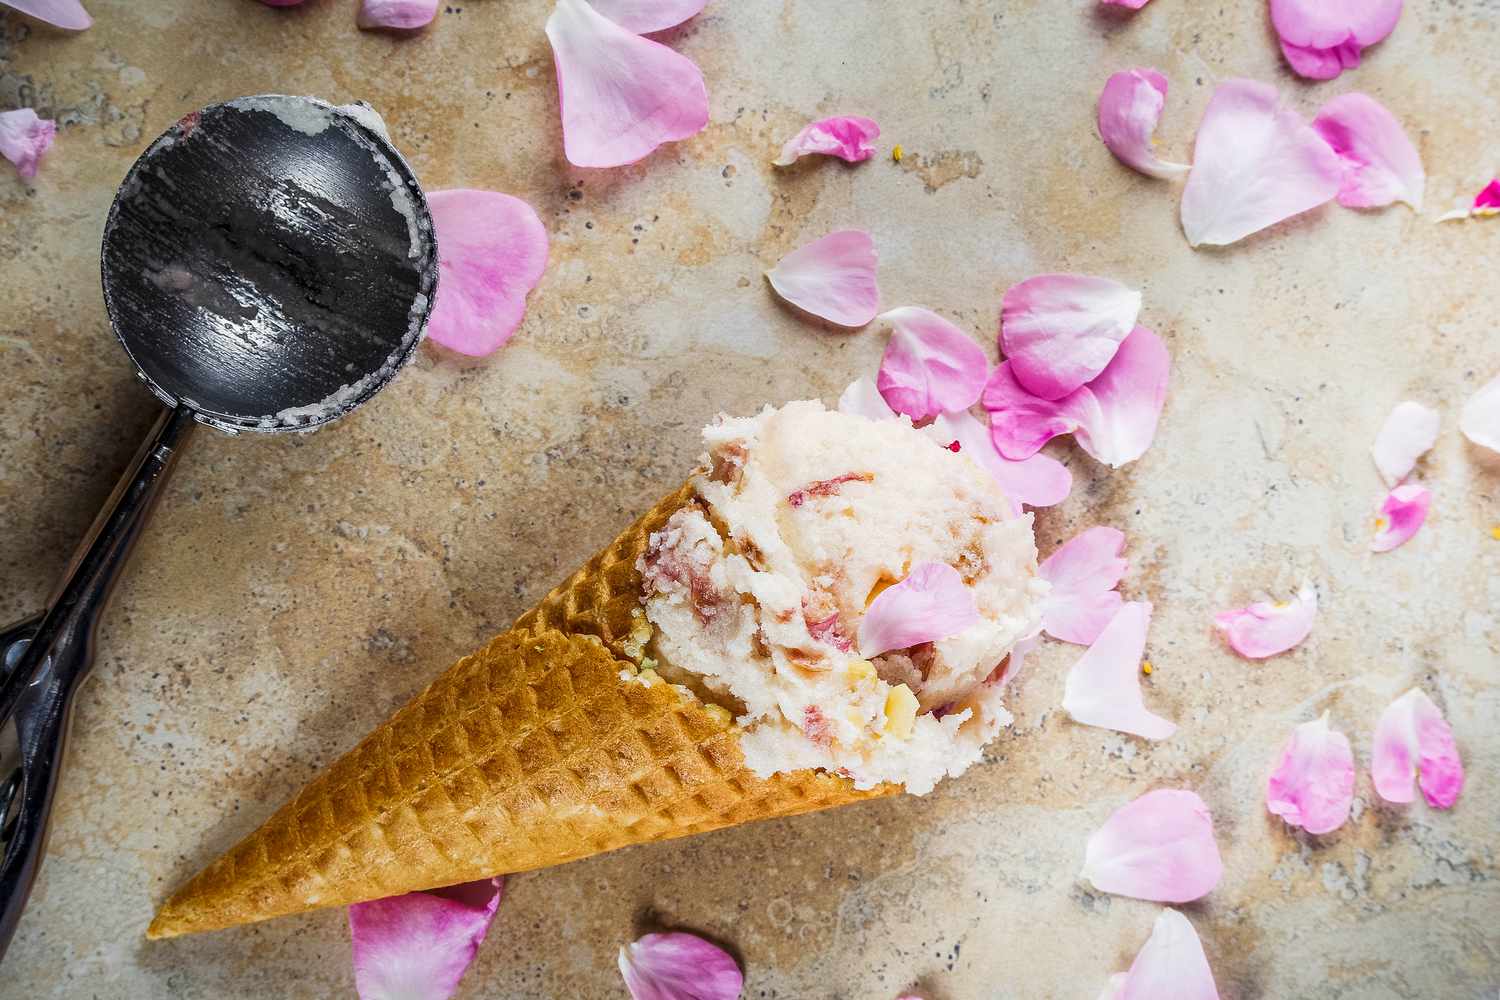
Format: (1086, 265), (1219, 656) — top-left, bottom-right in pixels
(1001, 274), (1140, 400)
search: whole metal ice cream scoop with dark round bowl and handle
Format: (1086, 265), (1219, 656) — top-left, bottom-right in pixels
(0, 96), (438, 955)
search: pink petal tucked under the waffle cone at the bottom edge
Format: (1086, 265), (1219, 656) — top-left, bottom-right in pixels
(350, 876), (506, 1000)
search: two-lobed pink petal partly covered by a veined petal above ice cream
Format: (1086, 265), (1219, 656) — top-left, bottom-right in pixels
(980, 327), (1172, 468)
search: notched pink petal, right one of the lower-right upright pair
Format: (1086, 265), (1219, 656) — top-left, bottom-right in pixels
(1370, 688), (1464, 810)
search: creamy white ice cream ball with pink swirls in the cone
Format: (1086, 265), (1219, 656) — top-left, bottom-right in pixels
(641, 402), (1046, 793)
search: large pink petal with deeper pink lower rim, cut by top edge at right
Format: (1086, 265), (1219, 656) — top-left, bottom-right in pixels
(1271, 0), (1401, 79)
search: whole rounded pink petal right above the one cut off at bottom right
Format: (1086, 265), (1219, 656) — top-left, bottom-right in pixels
(1083, 789), (1224, 903)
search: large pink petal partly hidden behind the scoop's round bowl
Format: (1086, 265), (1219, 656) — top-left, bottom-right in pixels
(428, 189), (548, 357)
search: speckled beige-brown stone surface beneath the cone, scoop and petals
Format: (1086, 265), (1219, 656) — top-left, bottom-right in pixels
(0, 0), (1500, 1000)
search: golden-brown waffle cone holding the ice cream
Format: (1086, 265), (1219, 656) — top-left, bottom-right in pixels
(147, 484), (894, 939)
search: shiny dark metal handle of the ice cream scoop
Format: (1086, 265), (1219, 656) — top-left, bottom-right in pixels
(0, 405), (194, 958)
